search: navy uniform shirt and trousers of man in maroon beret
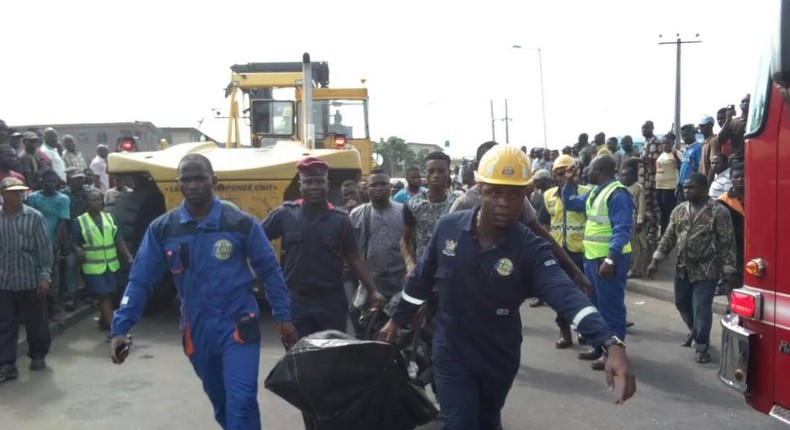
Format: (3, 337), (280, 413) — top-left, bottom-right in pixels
(263, 200), (358, 337)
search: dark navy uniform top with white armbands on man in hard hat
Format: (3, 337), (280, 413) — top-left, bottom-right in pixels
(393, 208), (614, 371)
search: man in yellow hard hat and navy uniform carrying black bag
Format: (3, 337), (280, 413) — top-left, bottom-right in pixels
(381, 145), (636, 430)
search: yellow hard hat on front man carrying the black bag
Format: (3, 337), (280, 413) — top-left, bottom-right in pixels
(477, 145), (532, 186)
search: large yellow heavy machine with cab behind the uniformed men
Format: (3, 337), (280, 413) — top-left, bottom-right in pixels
(106, 54), (374, 310)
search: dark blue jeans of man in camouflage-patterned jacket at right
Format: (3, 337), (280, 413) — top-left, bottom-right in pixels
(675, 277), (717, 351)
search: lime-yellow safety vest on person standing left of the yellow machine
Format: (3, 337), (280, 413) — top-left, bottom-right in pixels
(77, 212), (121, 275)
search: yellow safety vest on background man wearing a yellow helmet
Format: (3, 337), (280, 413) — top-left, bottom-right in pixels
(543, 185), (590, 252)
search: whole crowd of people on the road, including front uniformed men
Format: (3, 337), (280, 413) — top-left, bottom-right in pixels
(0, 101), (749, 429)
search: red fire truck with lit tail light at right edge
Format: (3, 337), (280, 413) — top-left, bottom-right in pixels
(719, 0), (790, 424)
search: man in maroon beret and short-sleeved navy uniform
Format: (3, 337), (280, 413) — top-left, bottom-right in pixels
(263, 157), (385, 336)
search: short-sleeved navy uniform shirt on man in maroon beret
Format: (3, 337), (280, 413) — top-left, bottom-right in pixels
(263, 200), (357, 294)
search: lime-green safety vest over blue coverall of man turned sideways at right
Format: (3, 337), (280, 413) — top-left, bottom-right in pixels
(583, 181), (631, 260)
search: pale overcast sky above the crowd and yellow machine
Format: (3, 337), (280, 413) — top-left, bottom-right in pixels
(0, 0), (768, 155)
